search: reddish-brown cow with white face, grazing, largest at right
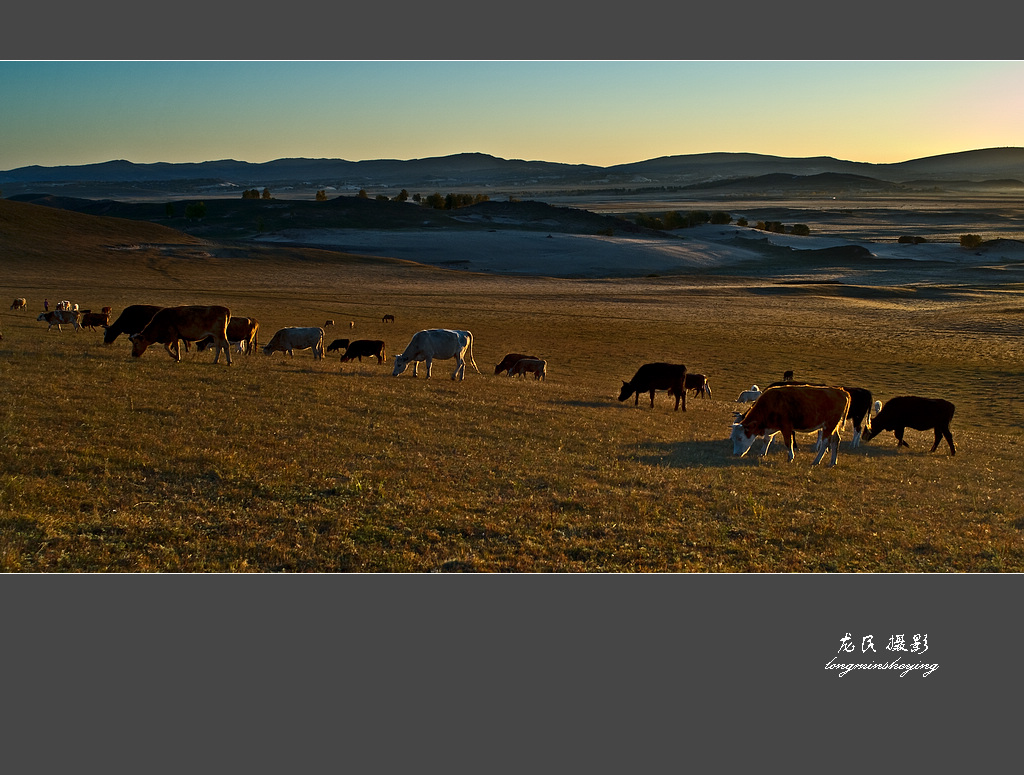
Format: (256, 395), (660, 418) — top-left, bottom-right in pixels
(730, 385), (850, 468)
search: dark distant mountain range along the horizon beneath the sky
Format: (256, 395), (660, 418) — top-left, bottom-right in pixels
(0, 147), (1024, 197)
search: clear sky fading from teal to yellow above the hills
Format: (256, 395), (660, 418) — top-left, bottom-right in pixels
(0, 60), (1024, 170)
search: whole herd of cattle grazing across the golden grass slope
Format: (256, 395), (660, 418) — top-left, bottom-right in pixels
(8, 299), (956, 466)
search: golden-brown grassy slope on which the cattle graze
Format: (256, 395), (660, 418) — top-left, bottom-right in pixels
(6, 196), (1024, 572)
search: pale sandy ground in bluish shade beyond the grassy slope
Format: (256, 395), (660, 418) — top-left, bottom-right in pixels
(253, 225), (1024, 283)
